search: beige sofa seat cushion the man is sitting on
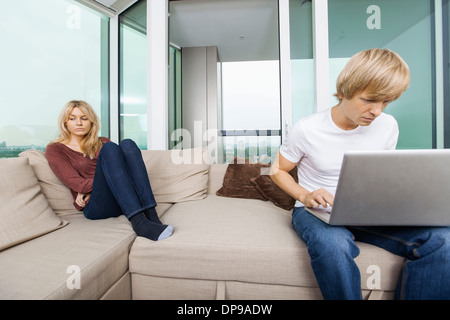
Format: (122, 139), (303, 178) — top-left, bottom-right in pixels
(130, 195), (403, 299)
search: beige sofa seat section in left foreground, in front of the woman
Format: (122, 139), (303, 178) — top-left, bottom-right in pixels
(0, 214), (136, 300)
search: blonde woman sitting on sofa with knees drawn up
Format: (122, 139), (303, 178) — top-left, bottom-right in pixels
(45, 100), (173, 241)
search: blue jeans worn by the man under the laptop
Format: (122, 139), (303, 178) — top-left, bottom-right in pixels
(292, 207), (450, 300)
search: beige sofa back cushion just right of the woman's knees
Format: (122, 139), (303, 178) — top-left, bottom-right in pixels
(142, 149), (209, 203)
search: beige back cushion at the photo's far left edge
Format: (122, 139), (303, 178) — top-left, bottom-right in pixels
(0, 158), (67, 250)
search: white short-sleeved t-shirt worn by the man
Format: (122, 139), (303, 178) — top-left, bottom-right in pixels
(280, 108), (399, 207)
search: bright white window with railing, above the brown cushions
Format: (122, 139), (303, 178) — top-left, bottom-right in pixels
(221, 60), (281, 162)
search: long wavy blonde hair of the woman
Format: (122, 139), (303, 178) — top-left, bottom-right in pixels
(52, 100), (103, 159)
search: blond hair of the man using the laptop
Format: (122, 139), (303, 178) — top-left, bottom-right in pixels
(335, 48), (410, 102)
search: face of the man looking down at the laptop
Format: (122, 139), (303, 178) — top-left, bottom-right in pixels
(341, 92), (391, 128)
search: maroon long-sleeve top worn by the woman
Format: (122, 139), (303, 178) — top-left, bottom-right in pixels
(45, 137), (110, 211)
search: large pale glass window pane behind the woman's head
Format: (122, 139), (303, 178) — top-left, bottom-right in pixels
(0, 0), (109, 157)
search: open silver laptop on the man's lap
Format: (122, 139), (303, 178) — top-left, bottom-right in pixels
(306, 149), (450, 226)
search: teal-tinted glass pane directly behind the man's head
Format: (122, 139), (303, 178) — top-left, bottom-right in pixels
(328, 0), (436, 149)
